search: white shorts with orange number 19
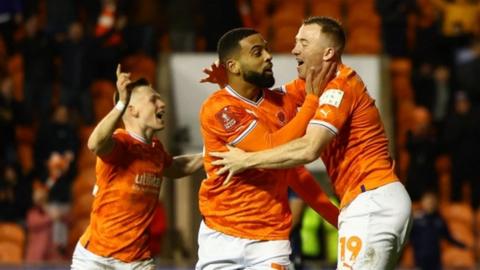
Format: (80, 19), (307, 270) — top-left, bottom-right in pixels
(337, 182), (412, 270)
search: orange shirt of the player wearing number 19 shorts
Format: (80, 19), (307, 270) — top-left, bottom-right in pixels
(283, 65), (398, 208)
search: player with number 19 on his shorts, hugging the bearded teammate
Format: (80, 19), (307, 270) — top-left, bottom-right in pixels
(210, 17), (411, 269)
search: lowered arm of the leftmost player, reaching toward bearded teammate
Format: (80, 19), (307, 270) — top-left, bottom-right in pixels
(163, 153), (203, 178)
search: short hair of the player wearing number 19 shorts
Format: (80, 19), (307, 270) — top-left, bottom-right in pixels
(303, 16), (347, 53)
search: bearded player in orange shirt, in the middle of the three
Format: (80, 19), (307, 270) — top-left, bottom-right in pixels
(196, 28), (338, 269)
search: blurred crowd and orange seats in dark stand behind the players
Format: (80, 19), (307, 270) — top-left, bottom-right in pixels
(0, 0), (480, 264)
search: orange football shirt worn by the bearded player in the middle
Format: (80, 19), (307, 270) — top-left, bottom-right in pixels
(199, 86), (318, 240)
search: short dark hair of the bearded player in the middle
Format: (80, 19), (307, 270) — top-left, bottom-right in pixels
(217, 27), (258, 64)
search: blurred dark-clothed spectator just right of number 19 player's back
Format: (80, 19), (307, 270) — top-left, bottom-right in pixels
(406, 107), (438, 201)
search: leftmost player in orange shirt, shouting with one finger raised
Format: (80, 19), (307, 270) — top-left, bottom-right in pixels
(72, 65), (203, 270)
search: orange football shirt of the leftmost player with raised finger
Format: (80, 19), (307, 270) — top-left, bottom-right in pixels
(80, 129), (172, 262)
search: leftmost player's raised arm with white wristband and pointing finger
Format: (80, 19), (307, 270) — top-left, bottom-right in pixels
(87, 65), (130, 156)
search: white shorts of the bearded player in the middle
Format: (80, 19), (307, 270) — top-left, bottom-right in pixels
(195, 221), (292, 270)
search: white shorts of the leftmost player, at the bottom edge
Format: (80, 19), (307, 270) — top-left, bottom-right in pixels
(71, 243), (155, 270)
